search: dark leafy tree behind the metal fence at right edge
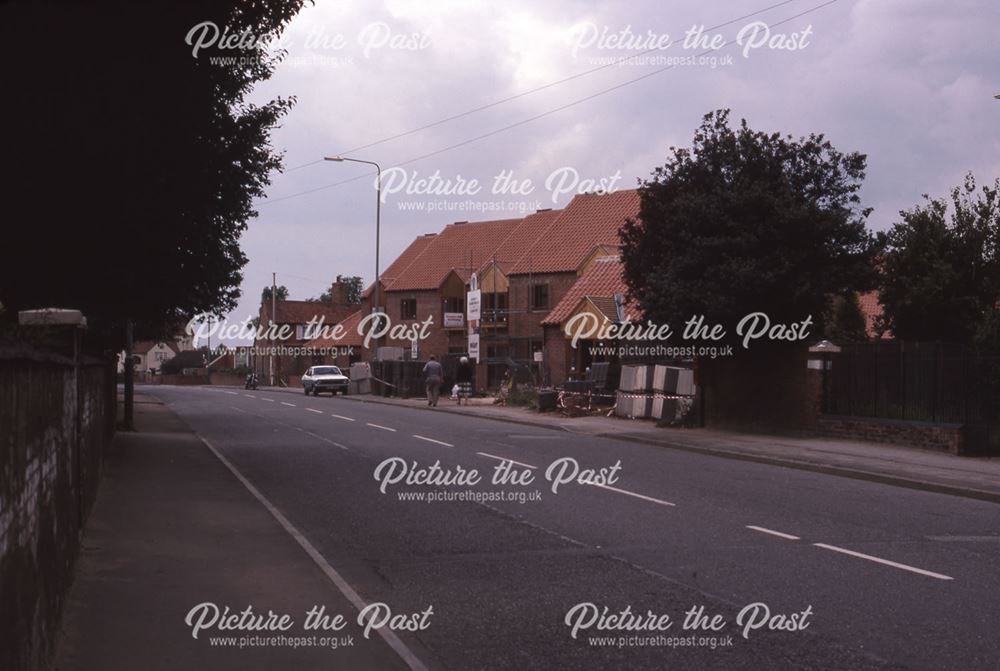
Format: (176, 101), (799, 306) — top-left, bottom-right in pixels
(879, 174), (1000, 349)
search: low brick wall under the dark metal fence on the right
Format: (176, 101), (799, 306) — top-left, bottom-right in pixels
(817, 415), (964, 454)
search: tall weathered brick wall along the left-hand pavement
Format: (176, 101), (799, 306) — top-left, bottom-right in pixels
(0, 349), (116, 671)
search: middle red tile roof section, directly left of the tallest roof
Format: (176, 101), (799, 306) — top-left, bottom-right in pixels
(386, 219), (523, 291)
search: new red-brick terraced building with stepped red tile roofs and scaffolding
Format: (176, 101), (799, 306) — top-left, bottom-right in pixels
(365, 190), (639, 387)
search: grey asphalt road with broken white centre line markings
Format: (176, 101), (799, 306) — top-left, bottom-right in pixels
(147, 387), (1000, 670)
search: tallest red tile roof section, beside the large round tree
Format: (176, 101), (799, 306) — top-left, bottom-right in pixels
(510, 189), (639, 275)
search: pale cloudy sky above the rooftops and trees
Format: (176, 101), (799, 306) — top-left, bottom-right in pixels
(231, 0), (1000, 334)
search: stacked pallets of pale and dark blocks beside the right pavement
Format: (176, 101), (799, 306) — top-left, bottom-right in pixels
(615, 364), (695, 421)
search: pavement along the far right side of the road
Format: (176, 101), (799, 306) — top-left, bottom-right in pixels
(252, 387), (1000, 503)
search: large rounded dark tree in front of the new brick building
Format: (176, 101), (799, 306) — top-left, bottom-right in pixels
(621, 110), (874, 342)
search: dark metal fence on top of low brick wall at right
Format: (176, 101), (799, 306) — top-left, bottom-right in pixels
(823, 341), (1000, 452)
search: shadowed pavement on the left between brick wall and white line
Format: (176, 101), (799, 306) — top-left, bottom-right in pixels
(52, 394), (418, 671)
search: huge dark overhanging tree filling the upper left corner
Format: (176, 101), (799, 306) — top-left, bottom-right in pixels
(0, 0), (302, 346)
